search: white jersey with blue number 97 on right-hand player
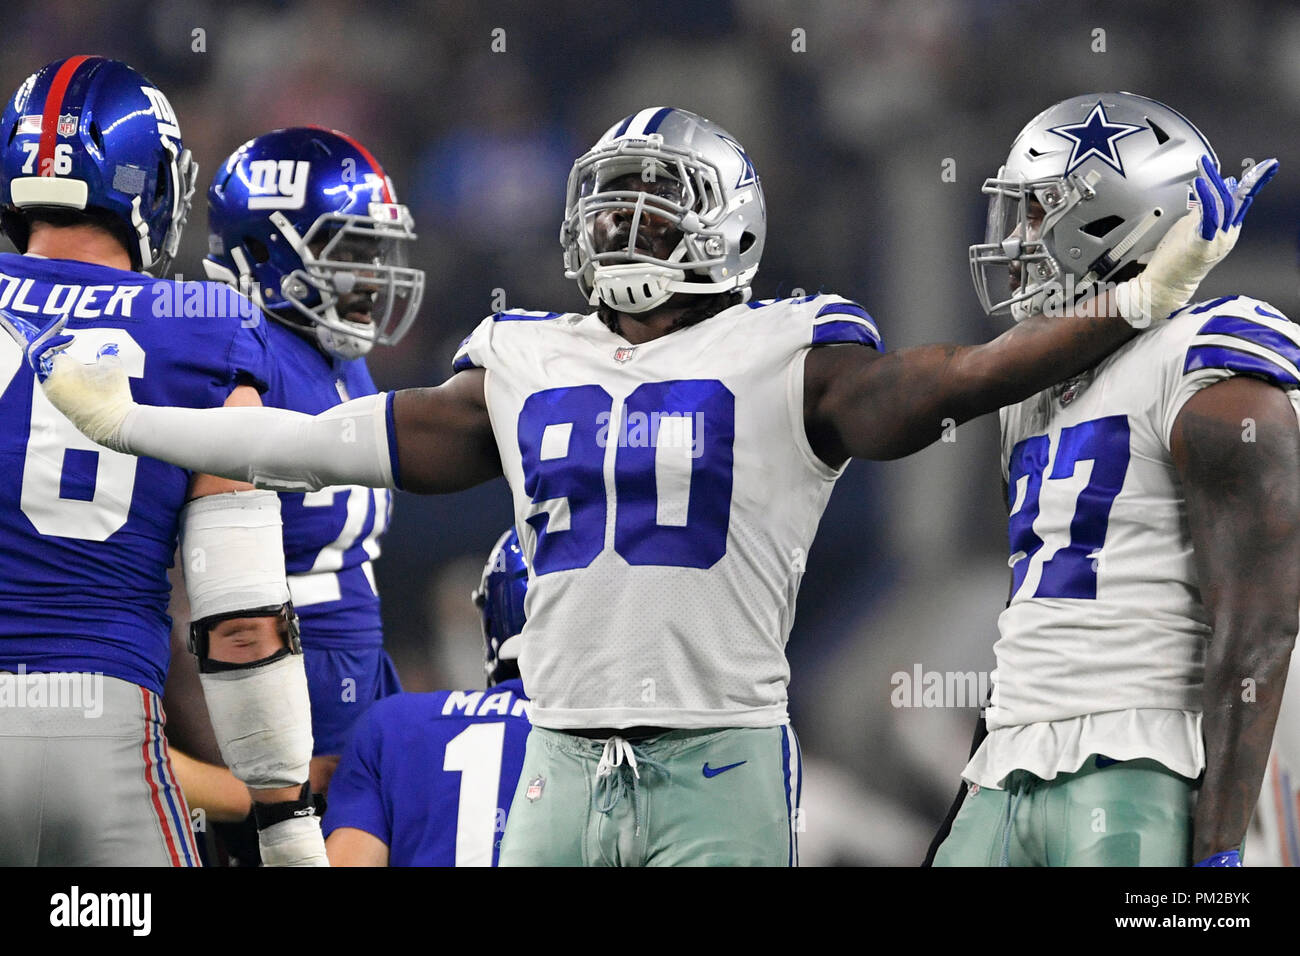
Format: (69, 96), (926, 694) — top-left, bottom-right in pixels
(965, 297), (1300, 787)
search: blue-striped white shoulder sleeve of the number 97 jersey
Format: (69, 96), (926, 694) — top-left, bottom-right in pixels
(1160, 295), (1300, 449)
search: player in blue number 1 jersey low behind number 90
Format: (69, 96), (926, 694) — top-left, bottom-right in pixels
(322, 528), (533, 866)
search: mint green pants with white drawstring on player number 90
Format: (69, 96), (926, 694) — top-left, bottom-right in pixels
(501, 727), (801, 866)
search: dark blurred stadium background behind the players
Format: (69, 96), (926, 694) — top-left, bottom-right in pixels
(0, 0), (1300, 865)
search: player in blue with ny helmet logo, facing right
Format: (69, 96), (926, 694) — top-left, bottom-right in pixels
(192, 126), (424, 792)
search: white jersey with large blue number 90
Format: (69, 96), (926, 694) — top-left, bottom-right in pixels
(454, 295), (880, 730)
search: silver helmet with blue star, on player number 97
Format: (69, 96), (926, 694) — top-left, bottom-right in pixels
(970, 92), (1218, 321)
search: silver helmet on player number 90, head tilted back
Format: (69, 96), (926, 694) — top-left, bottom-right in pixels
(560, 107), (767, 312)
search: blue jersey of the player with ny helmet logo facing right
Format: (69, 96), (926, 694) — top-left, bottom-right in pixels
(263, 321), (393, 650)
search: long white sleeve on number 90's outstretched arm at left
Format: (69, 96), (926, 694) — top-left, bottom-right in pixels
(120, 393), (394, 492)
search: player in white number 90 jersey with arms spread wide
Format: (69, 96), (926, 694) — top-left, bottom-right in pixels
(7, 107), (1260, 865)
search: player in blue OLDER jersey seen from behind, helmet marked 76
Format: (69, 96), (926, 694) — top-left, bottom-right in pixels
(0, 56), (325, 866)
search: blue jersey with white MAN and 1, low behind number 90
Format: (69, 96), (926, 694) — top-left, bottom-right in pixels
(322, 680), (529, 866)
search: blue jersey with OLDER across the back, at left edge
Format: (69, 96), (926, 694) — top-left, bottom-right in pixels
(0, 254), (269, 695)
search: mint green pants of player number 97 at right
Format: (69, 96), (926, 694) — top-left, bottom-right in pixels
(935, 754), (1196, 866)
